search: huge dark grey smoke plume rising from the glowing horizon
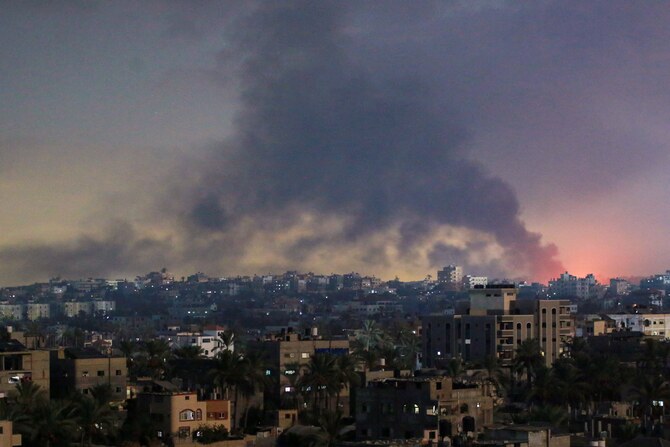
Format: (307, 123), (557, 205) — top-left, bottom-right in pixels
(181, 2), (562, 279)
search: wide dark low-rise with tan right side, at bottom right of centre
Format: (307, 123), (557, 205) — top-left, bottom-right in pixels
(355, 376), (493, 442)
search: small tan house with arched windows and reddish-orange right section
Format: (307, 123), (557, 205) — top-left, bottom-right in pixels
(137, 382), (231, 442)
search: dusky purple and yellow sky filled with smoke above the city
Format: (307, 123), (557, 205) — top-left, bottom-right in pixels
(0, 0), (670, 285)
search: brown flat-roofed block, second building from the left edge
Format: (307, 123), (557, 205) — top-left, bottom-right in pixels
(51, 348), (128, 401)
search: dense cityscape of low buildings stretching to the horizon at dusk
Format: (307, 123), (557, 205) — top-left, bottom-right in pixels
(0, 264), (670, 447)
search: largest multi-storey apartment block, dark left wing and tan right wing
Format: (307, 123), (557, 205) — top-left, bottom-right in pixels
(422, 284), (574, 367)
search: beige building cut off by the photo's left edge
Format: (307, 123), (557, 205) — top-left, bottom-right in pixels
(0, 340), (50, 395)
